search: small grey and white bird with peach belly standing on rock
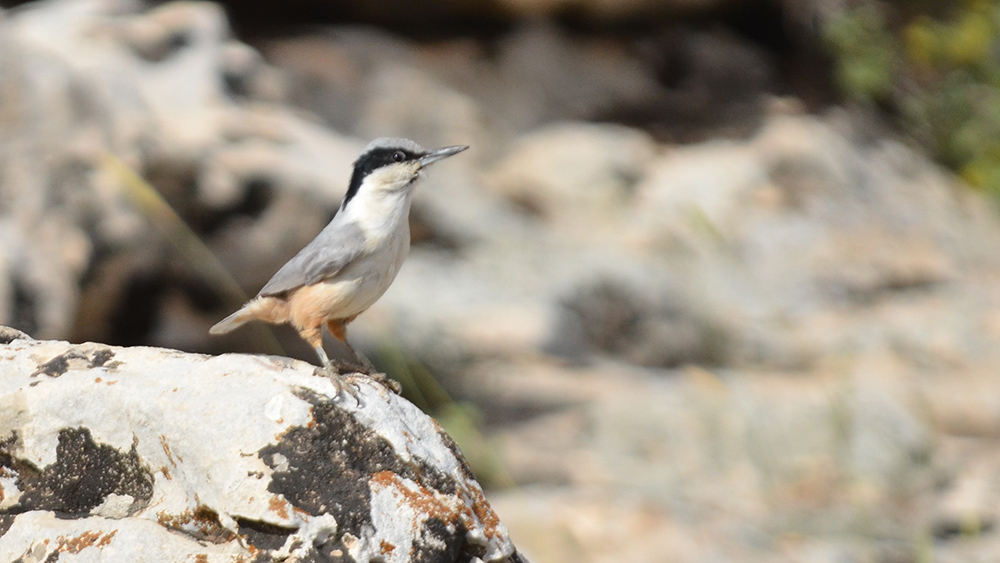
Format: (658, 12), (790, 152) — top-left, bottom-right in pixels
(209, 137), (469, 375)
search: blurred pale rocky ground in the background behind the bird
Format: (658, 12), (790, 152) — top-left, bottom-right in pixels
(0, 1), (1000, 562)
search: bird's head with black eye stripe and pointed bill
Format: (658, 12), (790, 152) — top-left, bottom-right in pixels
(341, 137), (469, 208)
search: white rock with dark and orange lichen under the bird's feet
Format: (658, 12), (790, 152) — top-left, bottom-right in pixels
(0, 335), (519, 562)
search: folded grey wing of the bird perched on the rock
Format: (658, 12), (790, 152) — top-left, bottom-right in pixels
(257, 221), (365, 296)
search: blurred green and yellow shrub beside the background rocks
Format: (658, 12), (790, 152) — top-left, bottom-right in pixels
(823, 0), (1000, 195)
